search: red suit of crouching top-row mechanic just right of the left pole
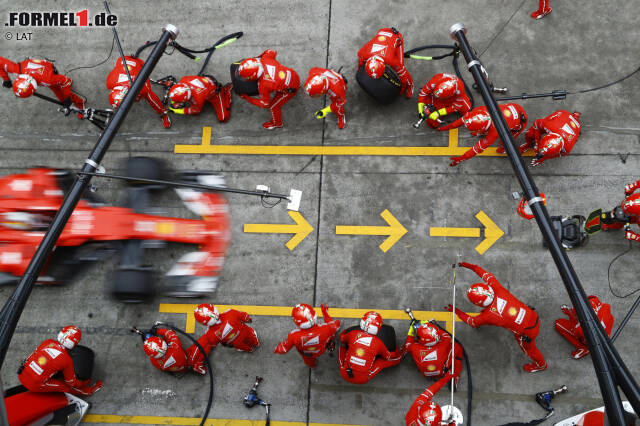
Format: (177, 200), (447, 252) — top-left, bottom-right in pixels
(174, 75), (232, 123)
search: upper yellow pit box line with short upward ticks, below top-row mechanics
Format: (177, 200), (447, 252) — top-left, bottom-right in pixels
(174, 127), (533, 157)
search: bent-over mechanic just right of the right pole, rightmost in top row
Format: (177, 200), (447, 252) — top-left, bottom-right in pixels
(519, 110), (582, 166)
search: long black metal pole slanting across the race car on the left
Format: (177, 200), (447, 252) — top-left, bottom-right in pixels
(0, 24), (178, 367)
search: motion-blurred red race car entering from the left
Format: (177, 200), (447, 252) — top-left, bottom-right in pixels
(0, 157), (231, 302)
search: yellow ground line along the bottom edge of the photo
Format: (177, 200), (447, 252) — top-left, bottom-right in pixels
(82, 414), (358, 426)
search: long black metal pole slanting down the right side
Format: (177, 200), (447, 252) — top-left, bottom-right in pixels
(449, 24), (635, 425)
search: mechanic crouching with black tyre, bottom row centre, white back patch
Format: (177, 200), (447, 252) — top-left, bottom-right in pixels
(338, 311), (404, 384)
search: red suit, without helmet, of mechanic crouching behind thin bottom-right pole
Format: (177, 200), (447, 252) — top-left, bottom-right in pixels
(404, 328), (462, 379)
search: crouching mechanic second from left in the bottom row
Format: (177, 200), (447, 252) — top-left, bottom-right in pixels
(143, 327), (188, 373)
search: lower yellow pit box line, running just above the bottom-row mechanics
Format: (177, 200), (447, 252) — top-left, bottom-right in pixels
(158, 303), (478, 333)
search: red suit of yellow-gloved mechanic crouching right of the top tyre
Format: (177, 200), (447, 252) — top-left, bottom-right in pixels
(418, 73), (471, 129)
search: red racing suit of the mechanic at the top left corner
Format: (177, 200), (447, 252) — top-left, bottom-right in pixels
(0, 57), (84, 109)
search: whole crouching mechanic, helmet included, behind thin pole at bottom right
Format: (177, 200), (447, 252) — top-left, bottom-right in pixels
(403, 321), (463, 386)
